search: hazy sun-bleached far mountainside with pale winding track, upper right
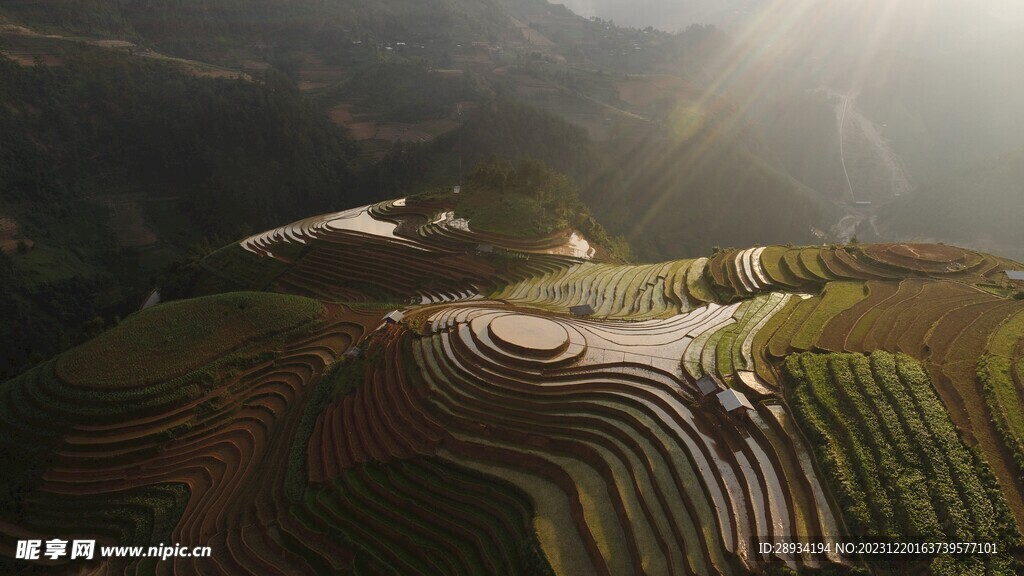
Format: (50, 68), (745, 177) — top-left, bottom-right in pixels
(700, 0), (1024, 257)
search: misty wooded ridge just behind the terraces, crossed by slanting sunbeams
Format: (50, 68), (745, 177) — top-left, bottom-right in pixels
(377, 98), (842, 260)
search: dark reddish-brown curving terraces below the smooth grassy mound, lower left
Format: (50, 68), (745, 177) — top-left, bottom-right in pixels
(2, 295), (379, 574)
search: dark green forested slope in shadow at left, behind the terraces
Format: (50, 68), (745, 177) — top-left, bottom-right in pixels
(0, 49), (369, 376)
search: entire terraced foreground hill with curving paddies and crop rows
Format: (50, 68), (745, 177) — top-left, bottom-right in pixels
(6, 194), (1024, 575)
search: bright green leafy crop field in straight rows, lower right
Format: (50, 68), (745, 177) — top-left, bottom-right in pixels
(785, 352), (1020, 574)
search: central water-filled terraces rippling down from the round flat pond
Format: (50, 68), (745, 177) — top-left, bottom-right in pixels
(391, 306), (835, 574)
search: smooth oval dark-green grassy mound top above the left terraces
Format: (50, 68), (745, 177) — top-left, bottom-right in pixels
(56, 292), (326, 387)
